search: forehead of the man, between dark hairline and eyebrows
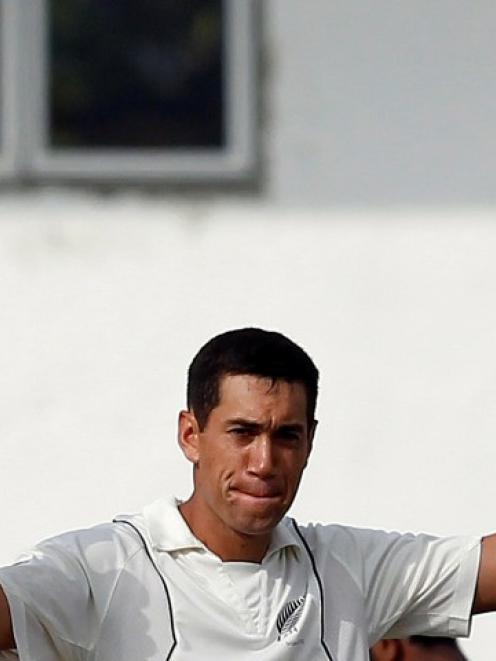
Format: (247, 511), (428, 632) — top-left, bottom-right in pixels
(217, 374), (307, 419)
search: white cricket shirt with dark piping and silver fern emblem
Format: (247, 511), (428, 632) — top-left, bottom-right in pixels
(0, 499), (480, 661)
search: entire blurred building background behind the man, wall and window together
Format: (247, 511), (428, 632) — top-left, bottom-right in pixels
(0, 0), (496, 661)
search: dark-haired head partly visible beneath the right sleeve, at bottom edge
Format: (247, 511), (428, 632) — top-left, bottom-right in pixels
(370, 636), (467, 661)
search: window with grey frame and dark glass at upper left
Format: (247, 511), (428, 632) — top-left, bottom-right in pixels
(0, 0), (255, 182)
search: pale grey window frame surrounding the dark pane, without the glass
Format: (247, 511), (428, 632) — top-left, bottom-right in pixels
(10, 0), (256, 184)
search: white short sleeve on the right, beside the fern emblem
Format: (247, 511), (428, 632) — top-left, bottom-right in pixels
(355, 531), (480, 641)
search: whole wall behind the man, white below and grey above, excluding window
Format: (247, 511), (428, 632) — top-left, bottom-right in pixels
(0, 0), (496, 661)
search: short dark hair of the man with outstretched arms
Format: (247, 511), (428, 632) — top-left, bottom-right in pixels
(187, 328), (319, 429)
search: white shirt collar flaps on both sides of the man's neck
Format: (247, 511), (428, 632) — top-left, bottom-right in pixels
(143, 497), (302, 559)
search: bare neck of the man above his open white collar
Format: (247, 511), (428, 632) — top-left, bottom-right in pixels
(179, 496), (271, 563)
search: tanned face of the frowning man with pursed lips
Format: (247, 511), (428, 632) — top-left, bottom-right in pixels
(182, 374), (314, 535)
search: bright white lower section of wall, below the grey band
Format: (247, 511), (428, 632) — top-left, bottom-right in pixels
(0, 199), (496, 661)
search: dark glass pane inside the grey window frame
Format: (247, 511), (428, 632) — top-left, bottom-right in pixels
(48, 0), (225, 148)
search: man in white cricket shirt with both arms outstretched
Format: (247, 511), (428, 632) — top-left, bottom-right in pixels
(0, 328), (496, 661)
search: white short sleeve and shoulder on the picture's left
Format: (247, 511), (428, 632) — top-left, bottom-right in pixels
(0, 525), (134, 661)
